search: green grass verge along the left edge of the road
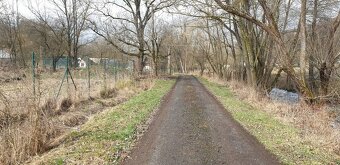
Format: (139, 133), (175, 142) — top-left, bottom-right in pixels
(32, 80), (175, 164)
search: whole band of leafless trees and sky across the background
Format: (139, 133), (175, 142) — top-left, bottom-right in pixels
(0, 0), (340, 102)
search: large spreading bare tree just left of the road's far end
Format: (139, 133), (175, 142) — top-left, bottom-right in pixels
(92, 0), (175, 74)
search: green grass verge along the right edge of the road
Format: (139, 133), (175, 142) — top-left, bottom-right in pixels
(200, 78), (339, 165)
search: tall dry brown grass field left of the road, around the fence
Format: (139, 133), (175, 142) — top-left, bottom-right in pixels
(0, 67), (153, 164)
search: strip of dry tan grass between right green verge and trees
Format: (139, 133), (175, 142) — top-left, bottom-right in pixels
(202, 73), (340, 159)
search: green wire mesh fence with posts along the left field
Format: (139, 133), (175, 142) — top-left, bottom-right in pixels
(0, 53), (133, 112)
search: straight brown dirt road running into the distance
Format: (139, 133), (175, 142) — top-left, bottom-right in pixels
(122, 76), (279, 165)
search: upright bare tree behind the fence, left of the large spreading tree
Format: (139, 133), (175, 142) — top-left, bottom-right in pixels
(29, 0), (92, 67)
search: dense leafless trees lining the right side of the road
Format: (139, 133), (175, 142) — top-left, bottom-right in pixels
(177, 0), (340, 102)
